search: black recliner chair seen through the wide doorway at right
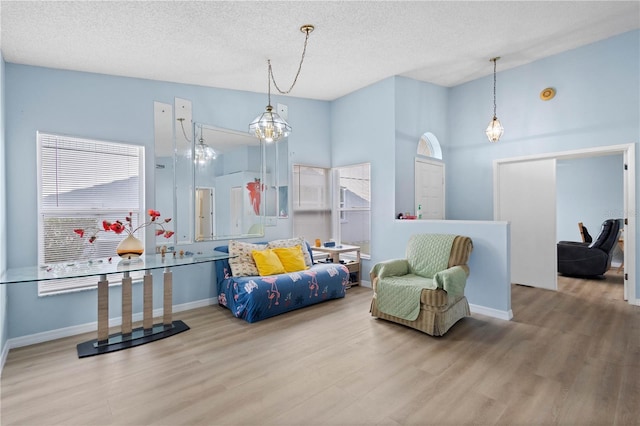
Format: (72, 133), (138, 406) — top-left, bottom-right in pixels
(558, 219), (622, 277)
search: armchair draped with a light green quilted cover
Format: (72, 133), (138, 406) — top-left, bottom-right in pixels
(371, 234), (473, 336)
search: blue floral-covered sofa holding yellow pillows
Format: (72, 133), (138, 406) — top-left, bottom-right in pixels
(214, 243), (349, 322)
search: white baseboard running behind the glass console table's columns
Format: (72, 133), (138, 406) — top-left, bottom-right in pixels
(2, 298), (218, 352)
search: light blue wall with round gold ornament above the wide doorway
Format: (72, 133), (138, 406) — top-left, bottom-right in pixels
(447, 31), (640, 295)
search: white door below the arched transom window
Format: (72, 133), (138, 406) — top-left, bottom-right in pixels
(415, 159), (444, 220)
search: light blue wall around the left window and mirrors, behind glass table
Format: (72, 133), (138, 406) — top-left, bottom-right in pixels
(3, 63), (331, 338)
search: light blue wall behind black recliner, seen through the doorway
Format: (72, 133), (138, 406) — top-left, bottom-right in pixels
(556, 155), (624, 241)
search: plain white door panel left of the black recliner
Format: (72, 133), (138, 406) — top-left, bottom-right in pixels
(495, 158), (558, 290)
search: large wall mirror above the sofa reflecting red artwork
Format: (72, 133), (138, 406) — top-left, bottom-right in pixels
(193, 122), (288, 242)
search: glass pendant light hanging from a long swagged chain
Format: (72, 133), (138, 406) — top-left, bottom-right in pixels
(249, 25), (315, 143)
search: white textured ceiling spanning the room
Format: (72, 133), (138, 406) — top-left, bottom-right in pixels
(0, 1), (640, 100)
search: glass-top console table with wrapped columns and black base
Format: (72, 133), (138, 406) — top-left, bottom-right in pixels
(0, 251), (229, 358)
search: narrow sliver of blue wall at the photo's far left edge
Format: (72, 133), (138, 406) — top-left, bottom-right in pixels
(0, 52), (9, 364)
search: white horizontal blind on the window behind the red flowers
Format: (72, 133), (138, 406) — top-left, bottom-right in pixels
(38, 132), (144, 295)
